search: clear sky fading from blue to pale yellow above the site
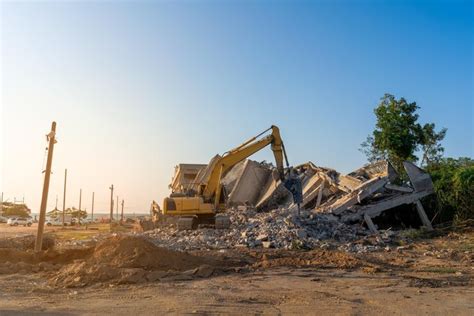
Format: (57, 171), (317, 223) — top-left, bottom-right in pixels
(1, 1), (474, 212)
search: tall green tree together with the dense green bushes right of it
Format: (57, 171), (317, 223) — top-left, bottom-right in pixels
(361, 94), (474, 223)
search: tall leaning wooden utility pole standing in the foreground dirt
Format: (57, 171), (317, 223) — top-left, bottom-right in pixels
(35, 122), (56, 252)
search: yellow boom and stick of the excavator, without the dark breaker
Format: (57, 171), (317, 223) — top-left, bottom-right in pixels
(200, 125), (289, 207)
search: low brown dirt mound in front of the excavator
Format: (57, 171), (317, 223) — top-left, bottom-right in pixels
(50, 235), (220, 287)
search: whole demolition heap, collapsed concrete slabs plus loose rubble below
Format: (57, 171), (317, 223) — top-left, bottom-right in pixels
(144, 159), (433, 252)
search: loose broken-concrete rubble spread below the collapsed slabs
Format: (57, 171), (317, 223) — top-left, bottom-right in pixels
(144, 207), (368, 250)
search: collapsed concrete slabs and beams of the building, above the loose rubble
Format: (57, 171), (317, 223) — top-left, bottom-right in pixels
(220, 160), (433, 233)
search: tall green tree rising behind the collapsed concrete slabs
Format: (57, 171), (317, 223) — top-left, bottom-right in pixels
(361, 94), (446, 175)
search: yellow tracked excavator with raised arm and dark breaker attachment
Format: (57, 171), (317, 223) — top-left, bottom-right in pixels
(161, 125), (301, 230)
